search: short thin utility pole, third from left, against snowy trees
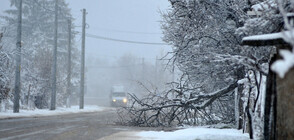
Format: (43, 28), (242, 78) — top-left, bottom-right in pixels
(66, 19), (71, 108)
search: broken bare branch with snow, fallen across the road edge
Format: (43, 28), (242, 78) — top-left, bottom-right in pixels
(119, 82), (238, 126)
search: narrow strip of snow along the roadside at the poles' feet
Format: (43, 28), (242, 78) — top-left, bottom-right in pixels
(0, 105), (106, 119)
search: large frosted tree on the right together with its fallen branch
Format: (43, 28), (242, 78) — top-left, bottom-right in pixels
(117, 0), (281, 136)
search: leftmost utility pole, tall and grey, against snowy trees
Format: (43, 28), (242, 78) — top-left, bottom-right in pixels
(13, 0), (22, 113)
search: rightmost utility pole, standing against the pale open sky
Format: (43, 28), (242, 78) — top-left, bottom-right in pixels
(80, 9), (86, 109)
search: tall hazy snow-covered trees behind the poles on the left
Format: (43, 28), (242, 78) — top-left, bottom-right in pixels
(1, 0), (78, 107)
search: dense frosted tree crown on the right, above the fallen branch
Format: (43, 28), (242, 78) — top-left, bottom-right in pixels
(163, 0), (250, 122)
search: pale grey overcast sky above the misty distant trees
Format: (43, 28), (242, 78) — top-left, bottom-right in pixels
(0, 0), (171, 62)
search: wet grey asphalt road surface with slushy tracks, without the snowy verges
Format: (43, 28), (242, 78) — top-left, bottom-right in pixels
(0, 109), (136, 140)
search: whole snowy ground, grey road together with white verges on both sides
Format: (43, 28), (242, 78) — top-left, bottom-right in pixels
(0, 106), (249, 140)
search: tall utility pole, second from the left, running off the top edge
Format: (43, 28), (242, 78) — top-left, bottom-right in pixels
(50, 0), (58, 110)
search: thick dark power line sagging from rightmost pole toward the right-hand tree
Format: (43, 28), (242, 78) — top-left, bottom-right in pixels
(86, 33), (168, 45)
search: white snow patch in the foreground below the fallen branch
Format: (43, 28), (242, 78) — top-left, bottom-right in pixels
(136, 127), (249, 140)
